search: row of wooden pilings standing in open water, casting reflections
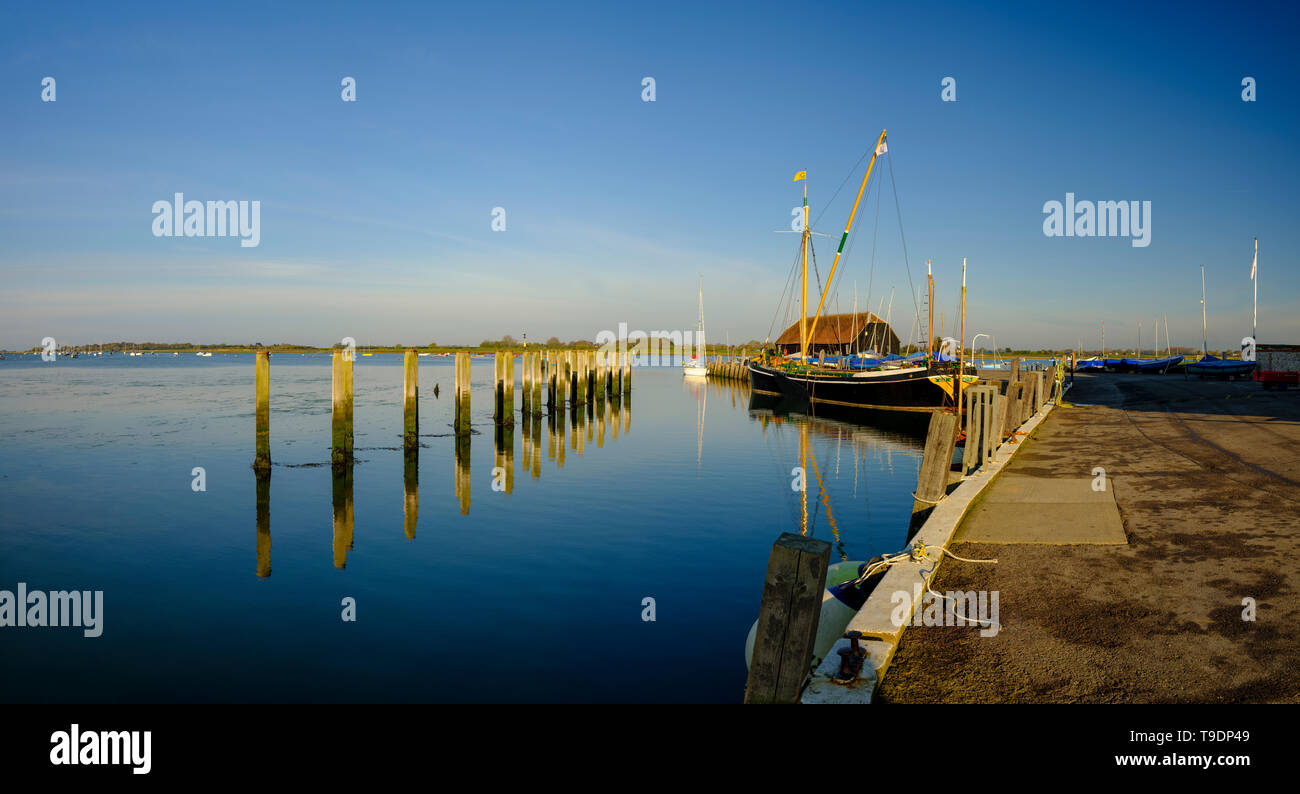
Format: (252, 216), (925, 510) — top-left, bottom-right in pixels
(252, 350), (632, 472)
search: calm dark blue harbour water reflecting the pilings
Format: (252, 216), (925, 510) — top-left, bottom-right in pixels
(0, 353), (920, 703)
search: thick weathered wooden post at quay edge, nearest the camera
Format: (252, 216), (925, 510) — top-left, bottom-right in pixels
(745, 535), (826, 703)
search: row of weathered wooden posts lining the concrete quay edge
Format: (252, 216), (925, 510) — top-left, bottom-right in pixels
(745, 359), (1065, 703)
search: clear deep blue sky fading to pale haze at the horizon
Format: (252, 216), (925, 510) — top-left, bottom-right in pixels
(0, 3), (1300, 348)
